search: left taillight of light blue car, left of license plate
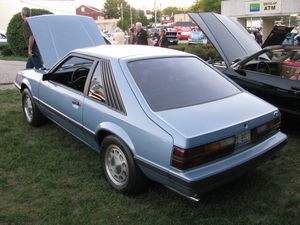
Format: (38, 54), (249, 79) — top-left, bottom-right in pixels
(172, 137), (235, 170)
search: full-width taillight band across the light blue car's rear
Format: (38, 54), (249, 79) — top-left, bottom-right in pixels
(171, 118), (281, 170)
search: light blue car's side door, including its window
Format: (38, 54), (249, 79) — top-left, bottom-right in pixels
(39, 56), (94, 139)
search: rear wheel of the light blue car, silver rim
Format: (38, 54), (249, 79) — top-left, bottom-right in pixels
(100, 135), (148, 194)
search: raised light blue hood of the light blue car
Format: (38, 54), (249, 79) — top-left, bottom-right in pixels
(28, 15), (105, 69)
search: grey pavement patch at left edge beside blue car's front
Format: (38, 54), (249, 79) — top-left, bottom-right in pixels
(0, 60), (26, 89)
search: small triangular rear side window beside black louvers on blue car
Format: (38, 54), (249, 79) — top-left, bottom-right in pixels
(88, 63), (106, 102)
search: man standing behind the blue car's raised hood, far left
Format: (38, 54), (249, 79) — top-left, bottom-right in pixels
(21, 7), (43, 69)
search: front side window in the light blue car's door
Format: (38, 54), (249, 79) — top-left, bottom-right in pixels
(51, 56), (93, 92)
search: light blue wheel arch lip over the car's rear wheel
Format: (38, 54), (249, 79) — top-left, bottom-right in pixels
(96, 122), (136, 155)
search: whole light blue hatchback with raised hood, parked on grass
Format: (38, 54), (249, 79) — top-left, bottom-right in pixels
(15, 15), (287, 200)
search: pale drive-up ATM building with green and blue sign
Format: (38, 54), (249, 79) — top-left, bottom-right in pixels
(221, 0), (300, 38)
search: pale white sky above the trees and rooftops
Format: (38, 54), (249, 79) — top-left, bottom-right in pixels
(0, 0), (195, 30)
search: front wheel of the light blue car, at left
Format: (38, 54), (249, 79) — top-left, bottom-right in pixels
(22, 89), (46, 126)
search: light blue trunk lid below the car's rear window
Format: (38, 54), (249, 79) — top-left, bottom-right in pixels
(156, 93), (277, 148)
